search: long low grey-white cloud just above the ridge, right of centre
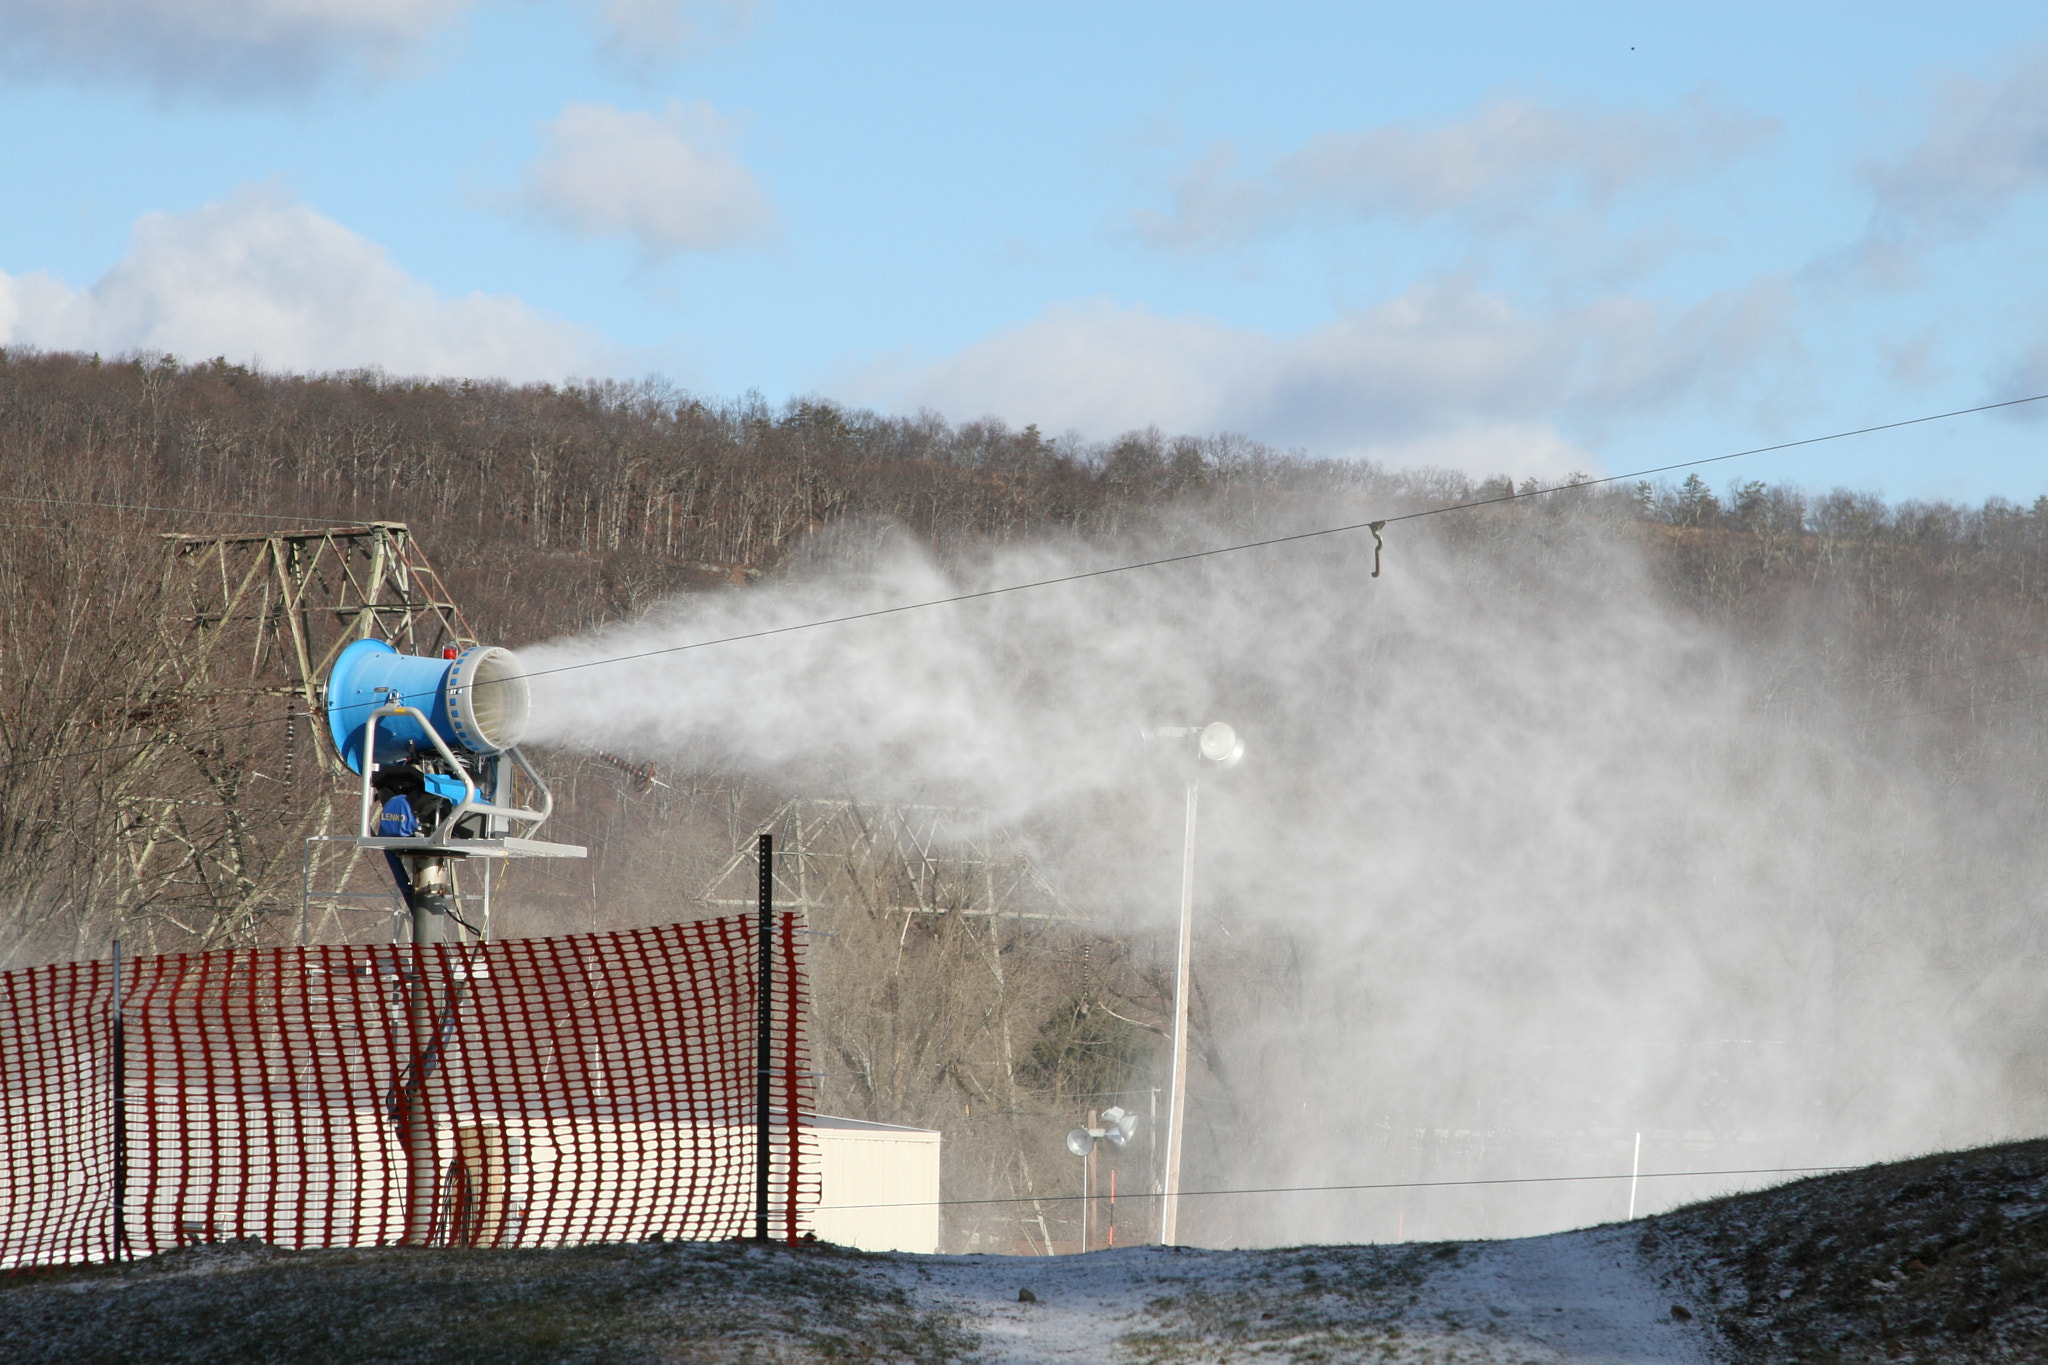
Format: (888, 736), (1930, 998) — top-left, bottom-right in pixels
(850, 280), (1792, 475)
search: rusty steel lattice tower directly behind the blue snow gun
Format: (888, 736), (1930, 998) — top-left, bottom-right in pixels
(117, 522), (473, 948)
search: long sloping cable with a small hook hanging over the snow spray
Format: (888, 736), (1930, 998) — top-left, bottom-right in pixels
(507, 393), (2048, 677)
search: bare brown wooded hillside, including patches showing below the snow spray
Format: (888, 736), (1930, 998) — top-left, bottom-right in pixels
(12, 350), (2048, 1236)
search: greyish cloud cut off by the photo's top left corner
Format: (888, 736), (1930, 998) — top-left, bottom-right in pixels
(0, 0), (471, 94)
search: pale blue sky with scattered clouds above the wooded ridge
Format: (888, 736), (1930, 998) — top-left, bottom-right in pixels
(0, 0), (2048, 501)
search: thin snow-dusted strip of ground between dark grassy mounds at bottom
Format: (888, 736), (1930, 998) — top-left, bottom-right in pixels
(877, 1228), (1714, 1365)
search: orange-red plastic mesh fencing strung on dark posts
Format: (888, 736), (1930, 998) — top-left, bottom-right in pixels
(0, 915), (817, 1269)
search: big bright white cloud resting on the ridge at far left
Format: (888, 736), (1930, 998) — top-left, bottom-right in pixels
(0, 190), (598, 381)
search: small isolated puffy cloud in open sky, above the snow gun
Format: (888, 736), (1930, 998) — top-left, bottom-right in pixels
(520, 100), (772, 258)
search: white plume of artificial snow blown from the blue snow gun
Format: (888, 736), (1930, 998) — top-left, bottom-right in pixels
(522, 501), (2048, 1244)
